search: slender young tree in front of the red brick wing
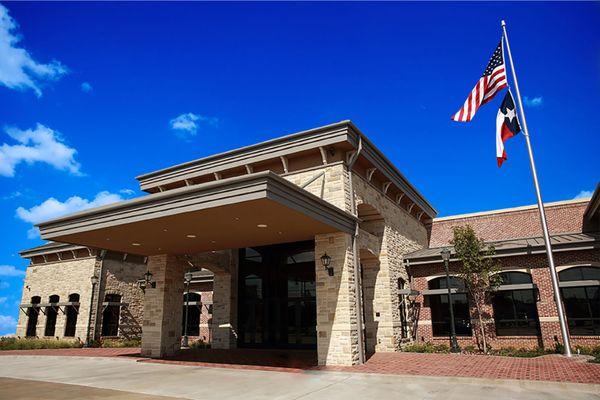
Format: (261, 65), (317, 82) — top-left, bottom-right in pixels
(450, 225), (500, 353)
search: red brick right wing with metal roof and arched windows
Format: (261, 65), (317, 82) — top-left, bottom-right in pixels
(404, 189), (600, 348)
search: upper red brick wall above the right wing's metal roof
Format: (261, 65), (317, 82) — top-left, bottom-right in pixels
(429, 201), (589, 247)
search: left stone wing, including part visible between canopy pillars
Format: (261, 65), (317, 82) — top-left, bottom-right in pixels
(16, 243), (212, 342)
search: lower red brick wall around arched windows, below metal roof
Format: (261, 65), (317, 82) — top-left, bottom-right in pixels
(410, 249), (600, 348)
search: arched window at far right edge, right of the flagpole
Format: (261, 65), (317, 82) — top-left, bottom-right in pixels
(558, 266), (600, 336)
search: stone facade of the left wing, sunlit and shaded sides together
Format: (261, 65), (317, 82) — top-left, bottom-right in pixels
(16, 248), (146, 341)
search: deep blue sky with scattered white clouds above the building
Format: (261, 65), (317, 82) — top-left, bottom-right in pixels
(0, 2), (600, 334)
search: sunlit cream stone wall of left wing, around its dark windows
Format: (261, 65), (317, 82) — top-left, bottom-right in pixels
(16, 256), (96, 341)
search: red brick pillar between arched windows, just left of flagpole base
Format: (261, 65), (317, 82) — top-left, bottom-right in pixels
(531, 266), (562, 349)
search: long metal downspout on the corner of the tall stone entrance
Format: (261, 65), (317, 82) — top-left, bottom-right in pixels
(347, 134), (365, 364)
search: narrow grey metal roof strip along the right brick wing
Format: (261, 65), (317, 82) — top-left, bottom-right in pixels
(404, 232), (600, 265)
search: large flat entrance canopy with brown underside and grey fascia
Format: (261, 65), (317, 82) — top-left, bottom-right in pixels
(38, 171), (356, 255)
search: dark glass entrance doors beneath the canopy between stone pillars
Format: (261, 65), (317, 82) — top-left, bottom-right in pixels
(238, 241), (317, 348)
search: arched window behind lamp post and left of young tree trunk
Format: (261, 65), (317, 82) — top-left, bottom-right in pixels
(427, 276), (471, 336)
